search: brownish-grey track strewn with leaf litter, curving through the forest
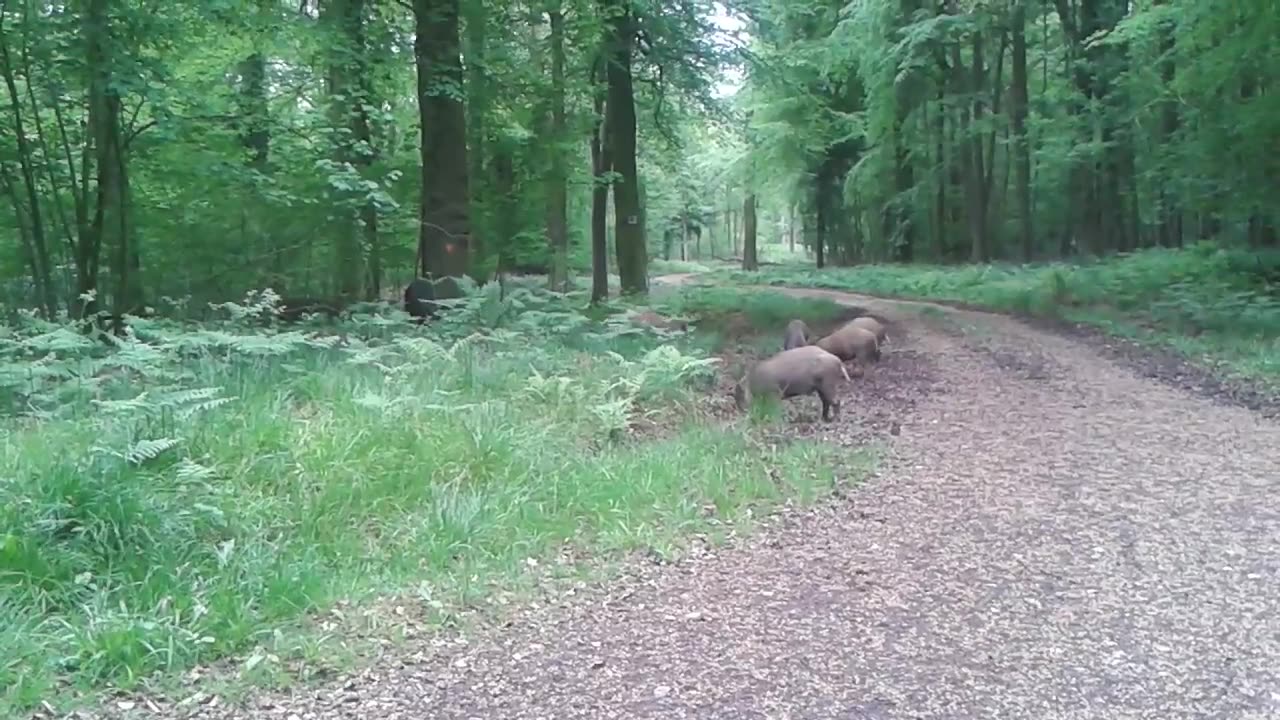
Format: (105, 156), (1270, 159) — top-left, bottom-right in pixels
(90, 275), (1280, 720)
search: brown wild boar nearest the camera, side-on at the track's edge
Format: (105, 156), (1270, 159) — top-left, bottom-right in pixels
(733, 345), (849, 423)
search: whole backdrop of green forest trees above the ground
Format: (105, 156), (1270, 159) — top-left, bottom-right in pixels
(0, 0), (1280, 315)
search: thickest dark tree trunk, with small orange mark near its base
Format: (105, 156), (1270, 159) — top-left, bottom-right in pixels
(413, 0), (471, 285)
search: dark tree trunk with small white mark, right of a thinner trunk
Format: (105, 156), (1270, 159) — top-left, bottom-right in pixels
(605, 0), (649, 295)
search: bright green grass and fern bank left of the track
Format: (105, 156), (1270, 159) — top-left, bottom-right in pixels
(0, 279), (870, 716)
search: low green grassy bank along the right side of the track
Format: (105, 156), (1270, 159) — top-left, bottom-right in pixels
(717, 243), (1280, 387)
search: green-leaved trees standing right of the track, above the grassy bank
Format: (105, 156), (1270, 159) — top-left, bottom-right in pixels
(740, 0), (1280, 264)
